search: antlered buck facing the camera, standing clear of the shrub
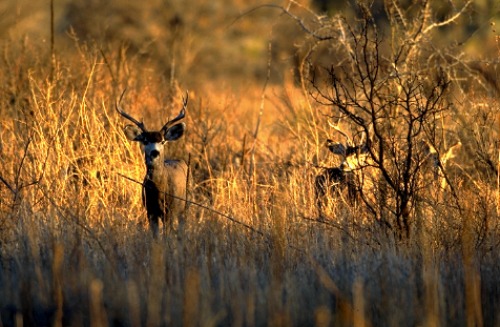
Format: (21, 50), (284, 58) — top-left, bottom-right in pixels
(116, 91), (188, 236)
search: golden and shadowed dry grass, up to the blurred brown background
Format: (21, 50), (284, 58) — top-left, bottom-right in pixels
(0, 3), (500, 326)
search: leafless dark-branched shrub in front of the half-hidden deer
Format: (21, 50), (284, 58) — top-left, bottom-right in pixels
(280, 2), (478, 240)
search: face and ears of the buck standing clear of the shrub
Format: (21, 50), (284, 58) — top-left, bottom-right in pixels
(123, 123), (186, 170)
